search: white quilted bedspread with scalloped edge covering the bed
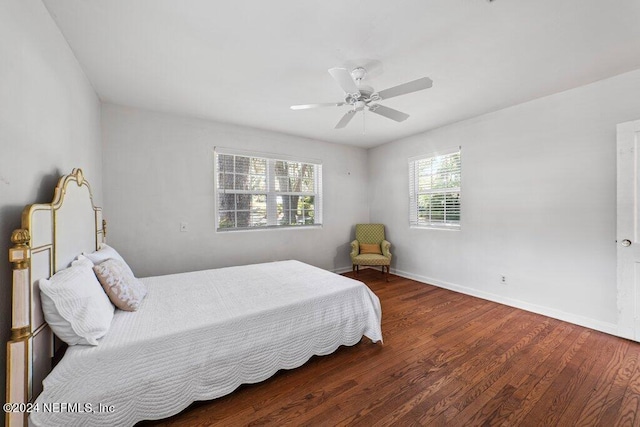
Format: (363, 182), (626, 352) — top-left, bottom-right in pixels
(30, 261), (382, 427)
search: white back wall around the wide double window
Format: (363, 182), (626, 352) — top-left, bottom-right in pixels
(102, 104), (369, 276)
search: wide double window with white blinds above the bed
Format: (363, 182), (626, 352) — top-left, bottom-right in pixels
(215, 150), (322, 231)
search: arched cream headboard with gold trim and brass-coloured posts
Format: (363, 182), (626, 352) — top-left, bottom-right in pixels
(5, 169), (106, 426)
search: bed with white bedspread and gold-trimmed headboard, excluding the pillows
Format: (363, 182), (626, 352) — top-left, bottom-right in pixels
(6, 169), (382, 426)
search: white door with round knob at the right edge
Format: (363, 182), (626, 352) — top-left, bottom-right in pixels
(616, 120), (640, 341)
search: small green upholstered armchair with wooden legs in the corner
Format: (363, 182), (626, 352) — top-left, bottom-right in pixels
(351, 224), (391, 281)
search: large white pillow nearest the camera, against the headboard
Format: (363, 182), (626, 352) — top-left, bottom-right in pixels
(39, 257), (115, 345)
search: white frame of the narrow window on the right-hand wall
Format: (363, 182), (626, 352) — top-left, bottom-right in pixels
(408, 147), (462, 231)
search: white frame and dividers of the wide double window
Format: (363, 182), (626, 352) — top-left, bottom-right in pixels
(213, 147), (323, 233)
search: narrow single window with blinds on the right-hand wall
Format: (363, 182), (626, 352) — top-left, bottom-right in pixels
(409, 148), (461, 228)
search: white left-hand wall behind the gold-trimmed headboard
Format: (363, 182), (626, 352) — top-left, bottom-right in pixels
(0, 0), (102, 421)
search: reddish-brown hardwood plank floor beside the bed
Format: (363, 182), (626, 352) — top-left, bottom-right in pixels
(144, 270), (640, 426)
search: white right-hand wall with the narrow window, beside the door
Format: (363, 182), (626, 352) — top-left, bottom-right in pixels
(369, 70), (640, 332)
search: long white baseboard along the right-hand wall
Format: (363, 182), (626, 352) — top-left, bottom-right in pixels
(391, 269), (619, 336)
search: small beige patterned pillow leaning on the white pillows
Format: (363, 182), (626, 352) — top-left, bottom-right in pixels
(93, 258), (147, 311)
